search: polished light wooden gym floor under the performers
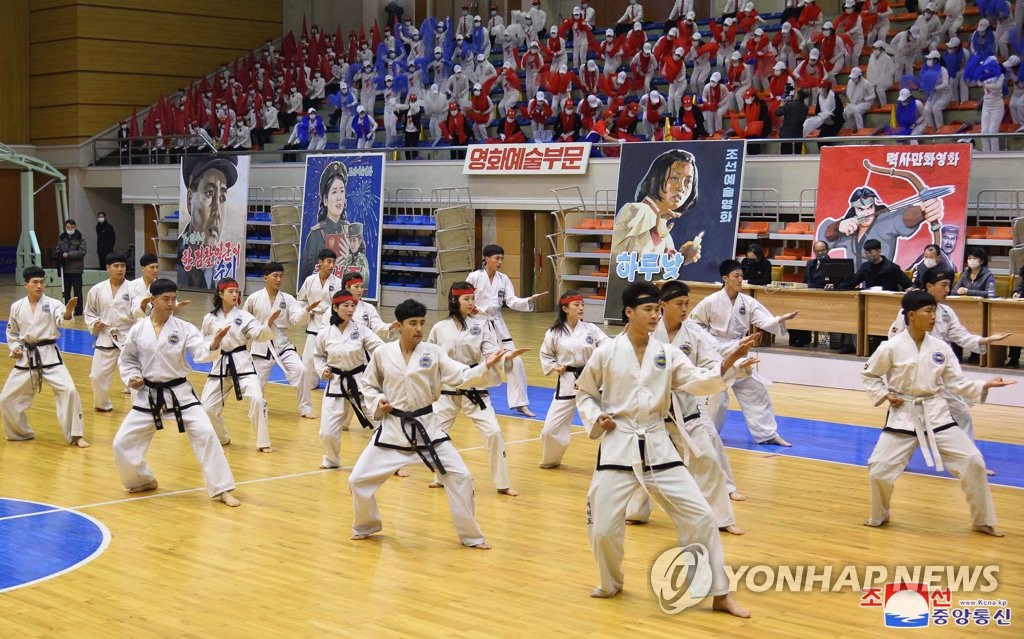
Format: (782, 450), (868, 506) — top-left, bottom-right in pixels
(0, 286), (1024, 638)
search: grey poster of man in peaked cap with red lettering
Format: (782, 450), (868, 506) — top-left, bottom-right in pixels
(177, 155), (249, 290)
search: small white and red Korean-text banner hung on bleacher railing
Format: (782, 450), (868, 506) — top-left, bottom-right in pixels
(462, 142), (590, 175)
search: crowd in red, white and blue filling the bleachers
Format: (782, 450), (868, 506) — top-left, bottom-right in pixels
(119, 0), (1024, 158)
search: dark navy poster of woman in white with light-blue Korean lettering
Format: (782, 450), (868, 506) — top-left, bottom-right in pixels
(604, 140), (745, 320)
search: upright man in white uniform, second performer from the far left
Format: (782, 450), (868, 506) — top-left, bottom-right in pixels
(83, 253), (138, 413)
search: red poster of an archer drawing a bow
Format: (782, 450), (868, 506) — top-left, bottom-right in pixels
(814, 144), (971, 272)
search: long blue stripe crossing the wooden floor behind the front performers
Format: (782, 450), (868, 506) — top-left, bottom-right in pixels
(8, 321), (1024, 487)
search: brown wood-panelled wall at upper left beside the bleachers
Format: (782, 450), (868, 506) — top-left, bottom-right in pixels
(28, 0), (284, 144)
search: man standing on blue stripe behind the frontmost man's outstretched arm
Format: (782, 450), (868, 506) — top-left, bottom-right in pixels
(690, 260), (798, 446)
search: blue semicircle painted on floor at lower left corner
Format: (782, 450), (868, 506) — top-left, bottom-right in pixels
(0, 498), (111, 593)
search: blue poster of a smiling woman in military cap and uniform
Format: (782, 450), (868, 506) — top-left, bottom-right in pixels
(299, 154), (384, 299)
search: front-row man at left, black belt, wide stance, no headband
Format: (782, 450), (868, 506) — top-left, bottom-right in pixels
(114, 278), (240, 507)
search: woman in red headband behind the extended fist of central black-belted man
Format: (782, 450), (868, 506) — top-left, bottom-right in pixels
(427, 282), (519, 497)
